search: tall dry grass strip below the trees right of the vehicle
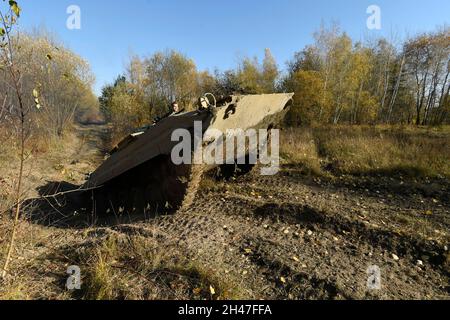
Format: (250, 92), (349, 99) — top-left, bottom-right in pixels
(282, 126), (450, 177)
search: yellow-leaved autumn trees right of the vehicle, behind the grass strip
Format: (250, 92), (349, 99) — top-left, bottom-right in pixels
(282, 27), (450, 125)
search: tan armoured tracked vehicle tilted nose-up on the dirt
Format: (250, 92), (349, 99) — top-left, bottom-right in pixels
(84, 94), (293, 214)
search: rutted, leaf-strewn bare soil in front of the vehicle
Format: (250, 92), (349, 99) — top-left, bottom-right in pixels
(99, 165), (449, 299)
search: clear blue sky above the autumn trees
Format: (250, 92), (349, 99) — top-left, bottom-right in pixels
(14, 0), (450, 93)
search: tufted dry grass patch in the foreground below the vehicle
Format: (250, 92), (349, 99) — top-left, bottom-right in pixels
(60, 235), (243, 300)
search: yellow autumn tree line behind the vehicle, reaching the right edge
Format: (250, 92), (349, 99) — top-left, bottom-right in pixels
(100, 26), (450, 130)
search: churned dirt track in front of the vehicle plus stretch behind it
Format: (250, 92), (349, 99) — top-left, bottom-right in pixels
(1, 126), (450, 299)
